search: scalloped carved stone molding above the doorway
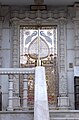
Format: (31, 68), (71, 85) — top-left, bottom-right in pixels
(11, 9), (67, 25)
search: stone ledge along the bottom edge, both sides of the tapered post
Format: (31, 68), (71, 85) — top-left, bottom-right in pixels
(0, 110), (79, 120)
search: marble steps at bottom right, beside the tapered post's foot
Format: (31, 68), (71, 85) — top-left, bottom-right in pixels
(50, 110), (79, 120)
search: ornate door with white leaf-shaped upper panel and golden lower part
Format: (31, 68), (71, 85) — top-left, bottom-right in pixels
(20, 26), (58, 108)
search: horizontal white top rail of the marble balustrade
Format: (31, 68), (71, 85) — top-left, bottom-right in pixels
(0, 68), (35, 75)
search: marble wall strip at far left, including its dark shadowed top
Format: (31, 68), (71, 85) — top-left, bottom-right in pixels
(0, 7), (12, 110)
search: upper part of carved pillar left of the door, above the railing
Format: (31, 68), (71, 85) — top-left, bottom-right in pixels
(12, 19), (20, 68)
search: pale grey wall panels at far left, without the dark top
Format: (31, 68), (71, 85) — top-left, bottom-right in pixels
(2, 28), (11, 110)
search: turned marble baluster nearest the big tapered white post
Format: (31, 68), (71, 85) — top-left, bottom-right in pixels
(23, 74), (28, 110)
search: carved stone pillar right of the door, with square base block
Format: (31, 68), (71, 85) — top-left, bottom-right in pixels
(58, 18), (69, 109)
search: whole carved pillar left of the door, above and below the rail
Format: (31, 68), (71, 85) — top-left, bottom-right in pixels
(12, 18), (20, 108)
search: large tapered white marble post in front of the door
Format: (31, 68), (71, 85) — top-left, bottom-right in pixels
(34, 66), (49, 120)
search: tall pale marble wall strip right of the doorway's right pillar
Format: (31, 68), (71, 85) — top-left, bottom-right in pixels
(67, 21), (74, 109)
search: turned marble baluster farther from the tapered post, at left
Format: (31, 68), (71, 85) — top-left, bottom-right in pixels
(7, 75), (13, 111)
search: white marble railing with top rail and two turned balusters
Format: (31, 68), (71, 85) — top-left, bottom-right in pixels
(0, 68), (35, 111)
